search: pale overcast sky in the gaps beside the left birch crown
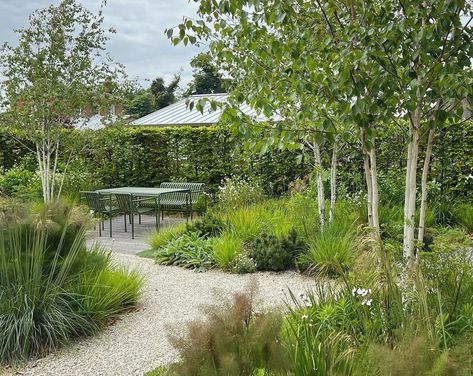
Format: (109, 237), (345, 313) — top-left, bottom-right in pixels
(0, 0), (199, 88)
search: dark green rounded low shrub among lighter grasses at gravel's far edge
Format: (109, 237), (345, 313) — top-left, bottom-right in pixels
(248, 230), (305, 271)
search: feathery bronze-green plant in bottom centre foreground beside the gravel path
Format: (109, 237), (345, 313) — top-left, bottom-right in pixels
(164, 289), (287, 376)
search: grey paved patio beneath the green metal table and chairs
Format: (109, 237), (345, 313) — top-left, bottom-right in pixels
(87, 215), (186, 255)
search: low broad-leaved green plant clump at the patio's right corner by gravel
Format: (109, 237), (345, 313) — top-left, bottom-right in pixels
(155, 232), (215, 271)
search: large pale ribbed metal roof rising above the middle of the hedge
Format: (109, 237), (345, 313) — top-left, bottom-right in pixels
(131, 93), (266, 126)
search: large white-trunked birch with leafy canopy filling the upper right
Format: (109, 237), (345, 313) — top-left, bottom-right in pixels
(171, 0), (473, 266)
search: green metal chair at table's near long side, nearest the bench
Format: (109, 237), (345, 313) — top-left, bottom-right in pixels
(115, 193), (159, 239)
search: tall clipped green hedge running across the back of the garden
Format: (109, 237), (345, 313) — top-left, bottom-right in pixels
(0, 122), (473, 201)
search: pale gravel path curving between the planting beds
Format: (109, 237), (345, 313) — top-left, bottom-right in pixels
(16, 253), (314, 376)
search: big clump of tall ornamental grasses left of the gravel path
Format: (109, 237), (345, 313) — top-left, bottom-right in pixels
(0, 203), (142, 364)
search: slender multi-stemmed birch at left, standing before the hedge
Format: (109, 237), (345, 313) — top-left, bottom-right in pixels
(0, 0), (121, 202)
